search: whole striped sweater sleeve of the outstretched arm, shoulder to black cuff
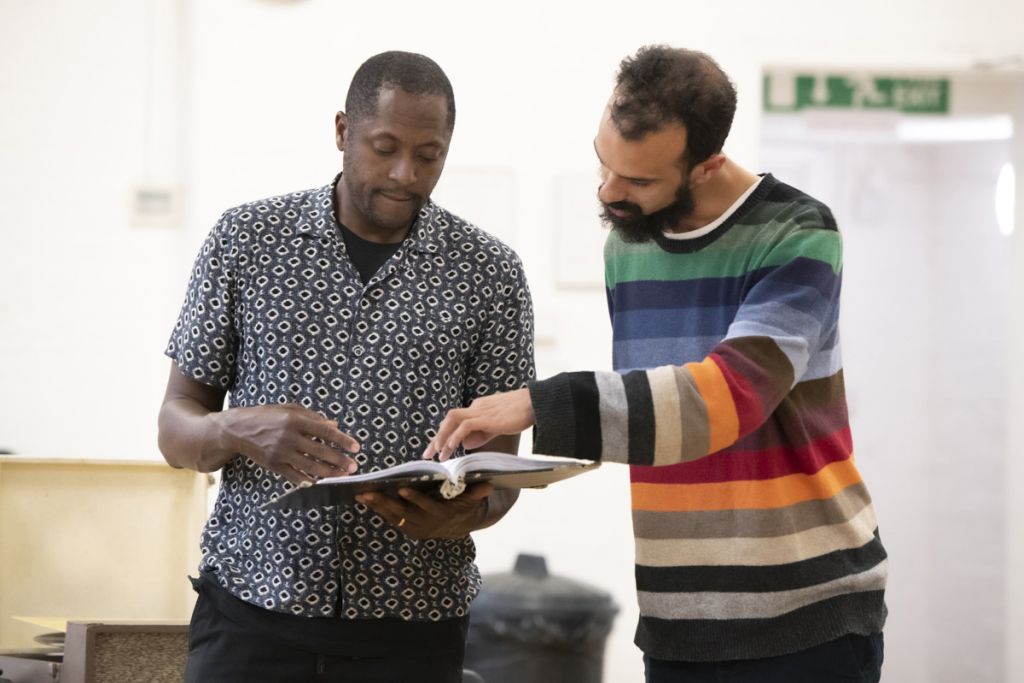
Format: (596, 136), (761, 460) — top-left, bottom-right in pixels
(529, 228), (842, 465)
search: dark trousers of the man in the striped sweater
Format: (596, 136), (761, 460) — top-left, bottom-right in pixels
(643, 633), (884, 683)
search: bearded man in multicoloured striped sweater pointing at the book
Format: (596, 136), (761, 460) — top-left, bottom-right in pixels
(424, 46), (887, 683)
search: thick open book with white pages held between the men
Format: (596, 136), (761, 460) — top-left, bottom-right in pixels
(266, 451), (600, 510)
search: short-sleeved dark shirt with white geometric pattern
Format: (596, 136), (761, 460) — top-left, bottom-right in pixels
(166, 179), (535, 621)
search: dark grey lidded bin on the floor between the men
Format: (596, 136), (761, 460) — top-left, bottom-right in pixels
(466, 554), (618, 683)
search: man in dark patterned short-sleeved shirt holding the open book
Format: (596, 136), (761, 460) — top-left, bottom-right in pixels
(160, 52), (534, 683)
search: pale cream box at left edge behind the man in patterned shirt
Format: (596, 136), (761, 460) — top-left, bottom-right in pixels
(0, 456), (209, 649)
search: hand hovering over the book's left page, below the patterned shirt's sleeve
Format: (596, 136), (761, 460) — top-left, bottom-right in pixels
(209, 403), (359, 485)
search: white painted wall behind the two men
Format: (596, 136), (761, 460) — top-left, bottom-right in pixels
(0, 0), (1024, 682)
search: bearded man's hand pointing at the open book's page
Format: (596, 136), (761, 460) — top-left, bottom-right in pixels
(423, 389), (534, 460)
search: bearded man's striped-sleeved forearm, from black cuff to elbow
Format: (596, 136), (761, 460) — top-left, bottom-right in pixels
(529, 336), (795, 466)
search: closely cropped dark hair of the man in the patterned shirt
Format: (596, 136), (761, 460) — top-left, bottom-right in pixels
(345, 50), (455, 131)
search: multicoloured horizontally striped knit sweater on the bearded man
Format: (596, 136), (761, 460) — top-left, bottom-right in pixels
(530, 175), (887, 661)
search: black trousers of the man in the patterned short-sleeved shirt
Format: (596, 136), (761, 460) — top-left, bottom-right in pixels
(184, 573), (468, 683)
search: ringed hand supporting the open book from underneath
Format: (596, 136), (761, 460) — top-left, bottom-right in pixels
(355, 483), (495, 539)
